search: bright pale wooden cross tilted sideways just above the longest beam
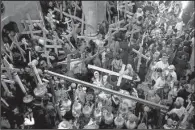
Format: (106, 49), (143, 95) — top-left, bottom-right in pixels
(88, 64), (133, 86)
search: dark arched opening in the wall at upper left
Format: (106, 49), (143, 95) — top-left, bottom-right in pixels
(2, 21), (19, 44)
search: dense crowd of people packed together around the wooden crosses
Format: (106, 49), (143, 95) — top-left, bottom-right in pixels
(1, 1), (195, 129)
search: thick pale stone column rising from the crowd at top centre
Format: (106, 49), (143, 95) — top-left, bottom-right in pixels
(82, 1), (106, 36)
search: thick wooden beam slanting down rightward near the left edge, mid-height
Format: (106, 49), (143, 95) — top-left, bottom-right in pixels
(3, 58), (27, 94)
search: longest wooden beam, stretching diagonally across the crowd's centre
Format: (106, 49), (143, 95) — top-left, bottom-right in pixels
(45, 70), (168, 111)
